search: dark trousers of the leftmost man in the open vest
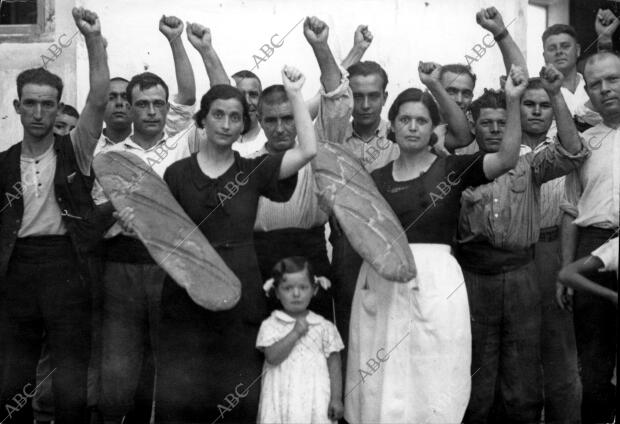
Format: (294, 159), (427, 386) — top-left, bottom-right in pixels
(0, 236), (91, 424)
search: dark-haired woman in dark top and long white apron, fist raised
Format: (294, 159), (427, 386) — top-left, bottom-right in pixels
(345, 64), (527, 423)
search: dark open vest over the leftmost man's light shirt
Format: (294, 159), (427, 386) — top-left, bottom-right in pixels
(0, 135), (105, 280)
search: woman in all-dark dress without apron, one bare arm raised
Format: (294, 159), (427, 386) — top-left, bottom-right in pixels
(150, 68), (316, 423)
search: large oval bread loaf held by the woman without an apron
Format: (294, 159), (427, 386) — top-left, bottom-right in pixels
(93, 151), (241, 311)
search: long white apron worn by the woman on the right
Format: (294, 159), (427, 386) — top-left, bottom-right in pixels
(344, 244), (471, 424)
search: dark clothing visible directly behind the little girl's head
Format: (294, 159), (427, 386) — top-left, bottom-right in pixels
(254, 225), (334, 321)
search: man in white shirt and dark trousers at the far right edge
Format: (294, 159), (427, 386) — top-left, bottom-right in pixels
(558, 52), (620, 423)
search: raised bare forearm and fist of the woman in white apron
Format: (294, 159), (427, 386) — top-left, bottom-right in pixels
(482, 65), (527, 180)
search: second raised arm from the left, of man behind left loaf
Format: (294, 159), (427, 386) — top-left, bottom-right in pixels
(159, 16), (196, 105)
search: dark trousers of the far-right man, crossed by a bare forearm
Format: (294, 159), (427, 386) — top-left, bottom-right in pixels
(573, 227), (618, 423)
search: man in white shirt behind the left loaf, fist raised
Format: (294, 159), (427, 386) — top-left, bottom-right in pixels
(93, 17), (195, 423)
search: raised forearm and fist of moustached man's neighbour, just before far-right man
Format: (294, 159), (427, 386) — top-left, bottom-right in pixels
(540, 64), (582, 155)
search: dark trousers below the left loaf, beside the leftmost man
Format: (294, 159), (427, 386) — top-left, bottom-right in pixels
(99, 261), (166, 423)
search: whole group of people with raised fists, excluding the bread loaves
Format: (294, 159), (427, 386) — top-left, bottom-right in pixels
(0, 7), (620, 424)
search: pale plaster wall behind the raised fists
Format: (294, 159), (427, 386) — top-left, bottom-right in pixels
(0, 0), (539, 150)
